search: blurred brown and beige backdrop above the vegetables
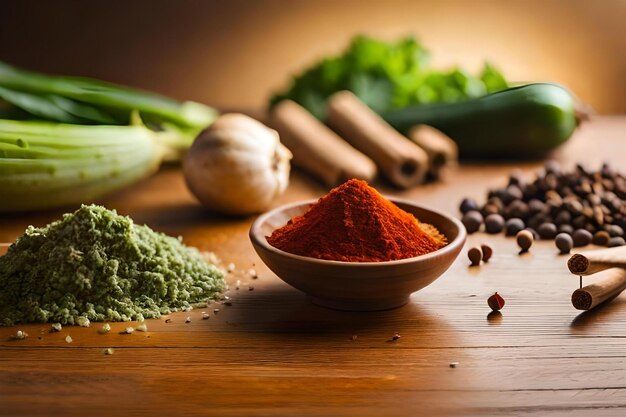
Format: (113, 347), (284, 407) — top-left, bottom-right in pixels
(0, 0), (626, 114)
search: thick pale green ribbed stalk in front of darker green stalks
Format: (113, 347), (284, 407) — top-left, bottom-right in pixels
(0, 119), (170, 212)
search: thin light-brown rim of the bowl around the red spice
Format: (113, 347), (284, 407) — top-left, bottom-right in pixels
(248, 196), (467, 268)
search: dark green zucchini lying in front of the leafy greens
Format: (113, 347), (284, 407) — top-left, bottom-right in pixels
(383, 83), (577, 159)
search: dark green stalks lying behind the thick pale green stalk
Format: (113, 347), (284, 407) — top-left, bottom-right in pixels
(0, 62), (217, 150)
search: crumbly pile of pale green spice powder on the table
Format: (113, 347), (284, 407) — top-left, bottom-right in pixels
(0, 205), (224, 325)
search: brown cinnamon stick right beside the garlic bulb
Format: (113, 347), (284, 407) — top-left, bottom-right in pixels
(270, 100), (377, 186)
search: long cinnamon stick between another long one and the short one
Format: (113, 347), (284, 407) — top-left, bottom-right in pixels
(327, 91), (428, 188)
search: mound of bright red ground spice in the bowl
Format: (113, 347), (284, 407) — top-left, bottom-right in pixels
(267, 179), (447, 262)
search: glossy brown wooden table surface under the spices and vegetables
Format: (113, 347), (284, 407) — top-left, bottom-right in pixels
(0, 117), (626, 417)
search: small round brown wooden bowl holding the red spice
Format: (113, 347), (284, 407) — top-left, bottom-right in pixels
(250, 198), (466, 311)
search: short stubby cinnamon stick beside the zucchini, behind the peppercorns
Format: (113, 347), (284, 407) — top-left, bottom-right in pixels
(408, 125), (459, 179)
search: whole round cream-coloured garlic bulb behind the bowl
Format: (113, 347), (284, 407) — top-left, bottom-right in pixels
(183, 113), (291, 215)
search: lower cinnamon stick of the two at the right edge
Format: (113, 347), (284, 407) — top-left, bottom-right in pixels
(572, 268), (626, 310)
